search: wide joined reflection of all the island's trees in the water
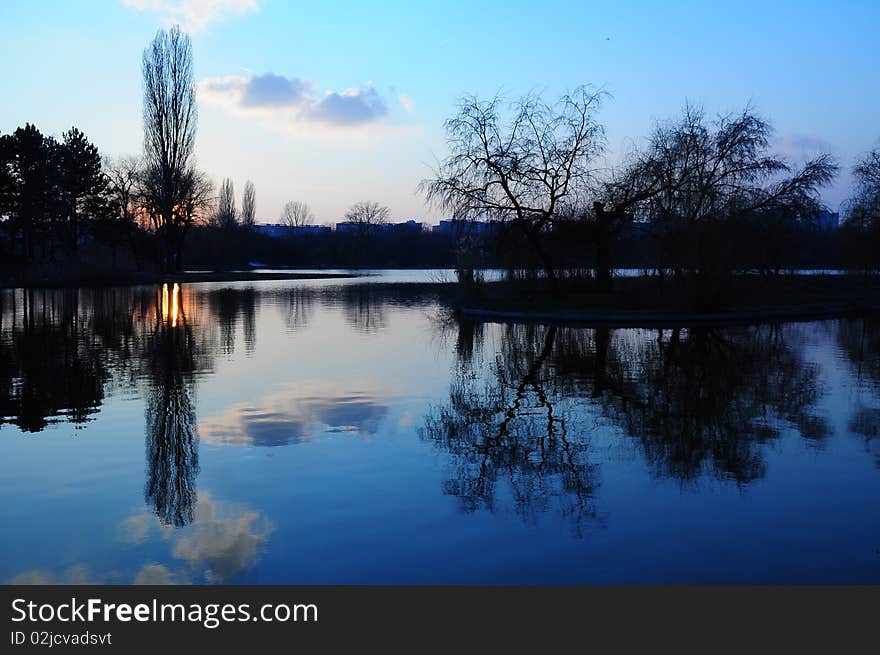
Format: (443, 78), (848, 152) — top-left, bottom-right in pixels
(422, 320), (830, 524)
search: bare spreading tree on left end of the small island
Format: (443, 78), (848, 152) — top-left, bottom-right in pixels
(420, 86), (605, 290)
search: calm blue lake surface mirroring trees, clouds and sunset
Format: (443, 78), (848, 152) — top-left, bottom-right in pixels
(0, 271), (880, 584)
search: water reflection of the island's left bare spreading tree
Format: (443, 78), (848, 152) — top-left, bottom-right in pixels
(421, 322), (596, 530)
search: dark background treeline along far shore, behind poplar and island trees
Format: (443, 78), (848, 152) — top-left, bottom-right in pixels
(0, 115), (868, 278)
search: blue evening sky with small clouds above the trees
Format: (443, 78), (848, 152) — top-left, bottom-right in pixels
(0, 0), (880, 222)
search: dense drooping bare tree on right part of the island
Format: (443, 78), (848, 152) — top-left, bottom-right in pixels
(611, 105), (837, 309)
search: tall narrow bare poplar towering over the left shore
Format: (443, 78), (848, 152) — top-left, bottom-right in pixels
(140, 26), (199, 270)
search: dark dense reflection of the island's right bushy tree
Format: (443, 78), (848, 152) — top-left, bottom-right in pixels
(600, 326), (829, 484)
